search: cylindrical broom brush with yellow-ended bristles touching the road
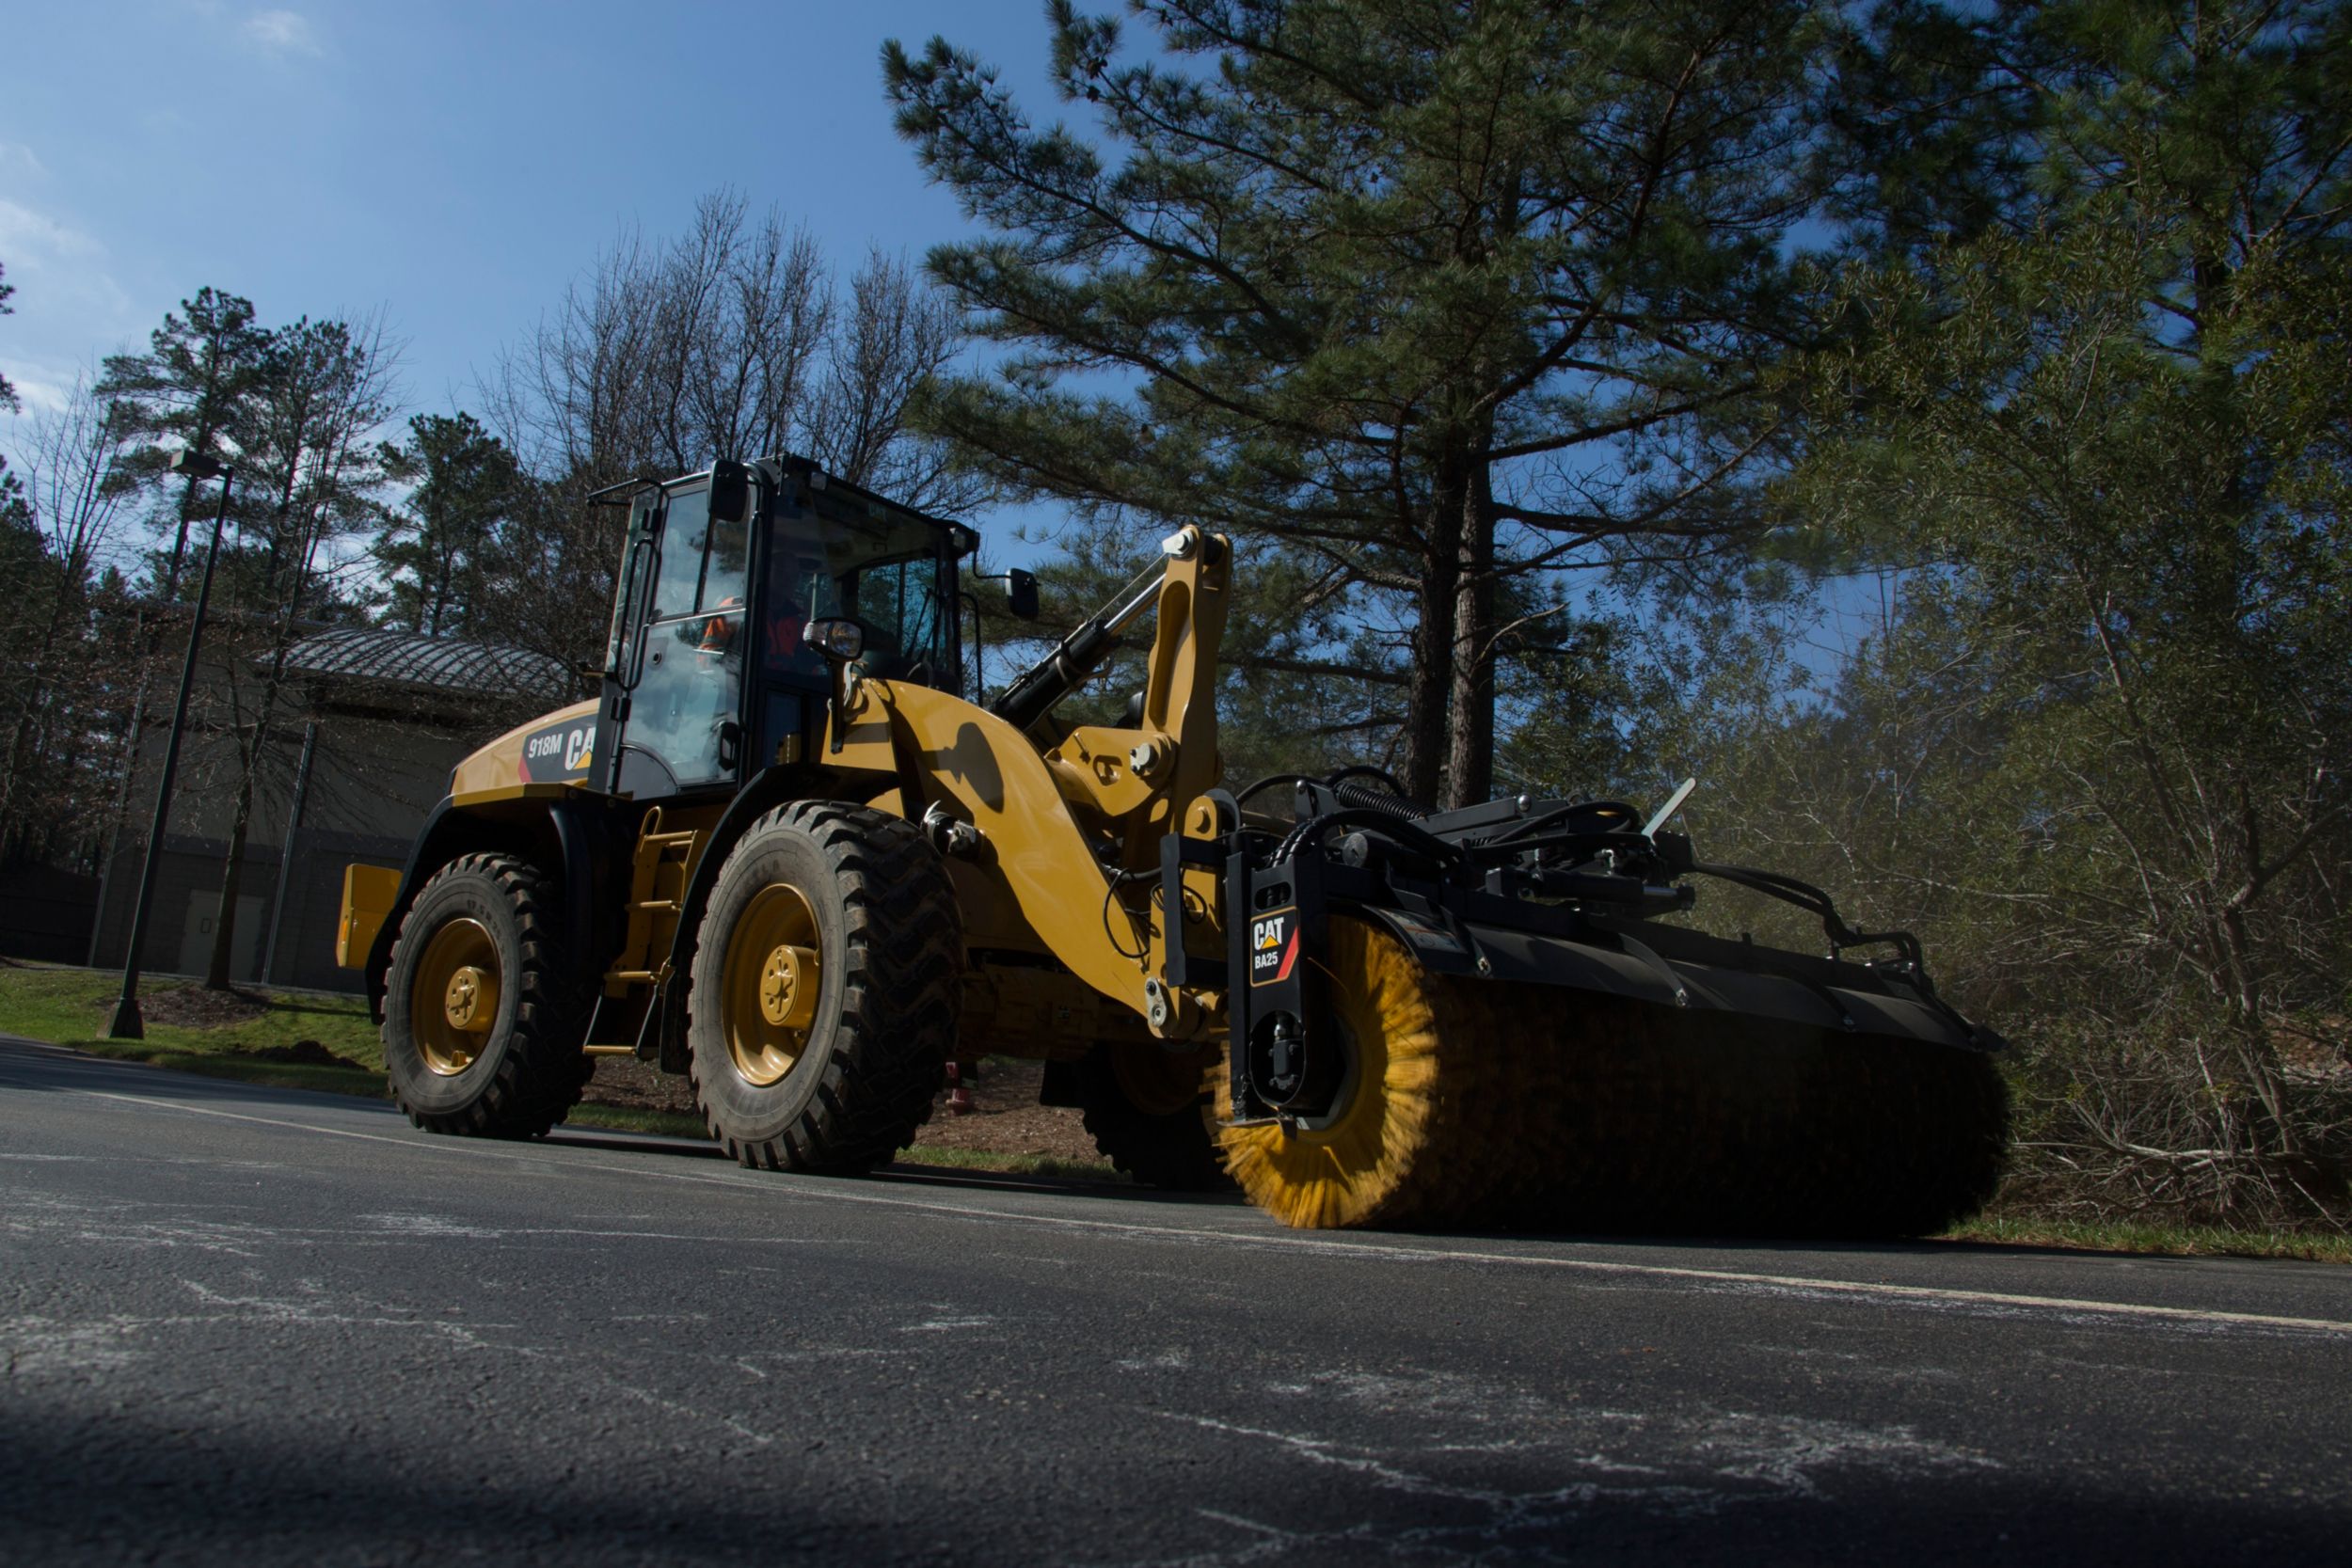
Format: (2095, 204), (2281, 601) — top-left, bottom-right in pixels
(1218, 917), (2007, 1234)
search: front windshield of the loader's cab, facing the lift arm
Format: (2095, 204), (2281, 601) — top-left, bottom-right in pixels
(767, 508), (955, 687)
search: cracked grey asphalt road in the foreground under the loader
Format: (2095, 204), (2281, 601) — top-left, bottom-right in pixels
(0, 1041), (2352, 1568)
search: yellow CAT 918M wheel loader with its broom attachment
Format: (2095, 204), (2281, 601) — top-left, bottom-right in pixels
(339, 458), (2007, 1234)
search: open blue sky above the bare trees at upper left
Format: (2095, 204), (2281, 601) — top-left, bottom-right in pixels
(0, 0), (1058, 425)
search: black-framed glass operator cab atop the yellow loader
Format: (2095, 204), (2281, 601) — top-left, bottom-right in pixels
(596, 458), (978, 800)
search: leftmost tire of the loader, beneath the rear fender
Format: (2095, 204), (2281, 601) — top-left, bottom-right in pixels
(384, 856), (593, 1138)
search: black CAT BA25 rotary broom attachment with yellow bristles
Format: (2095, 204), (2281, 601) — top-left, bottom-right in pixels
(1204, 768), (2009, 1237)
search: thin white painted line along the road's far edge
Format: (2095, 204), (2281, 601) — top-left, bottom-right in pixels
(50, 1088), (2352, 1336)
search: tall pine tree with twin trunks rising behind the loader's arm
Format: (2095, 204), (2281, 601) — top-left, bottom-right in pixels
(884, 0), (1814, 801)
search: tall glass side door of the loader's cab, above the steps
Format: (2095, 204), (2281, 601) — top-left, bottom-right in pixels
(607, 470), (757, 800)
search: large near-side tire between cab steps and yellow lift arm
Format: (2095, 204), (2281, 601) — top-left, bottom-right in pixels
(687, 801), (964, 1173)
